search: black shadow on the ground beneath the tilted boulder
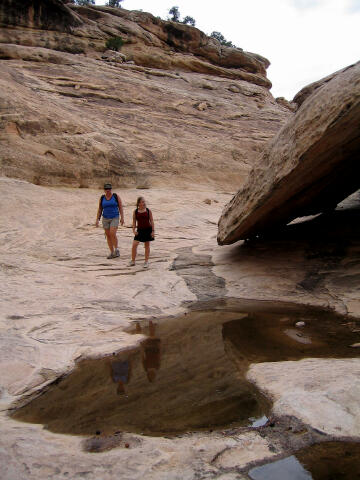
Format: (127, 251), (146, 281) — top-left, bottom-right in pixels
(235, 192), (360, 292)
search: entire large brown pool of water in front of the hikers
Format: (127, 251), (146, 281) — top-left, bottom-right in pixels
(12, 300), (360, 435)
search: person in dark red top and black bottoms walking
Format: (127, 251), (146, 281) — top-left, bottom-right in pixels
(129, 197), (155, 268)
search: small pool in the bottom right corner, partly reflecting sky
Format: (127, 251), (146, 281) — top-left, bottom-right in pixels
(249, 442), (360, 480)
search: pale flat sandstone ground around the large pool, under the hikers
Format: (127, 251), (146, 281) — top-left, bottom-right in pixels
(0, 178), (360, 480)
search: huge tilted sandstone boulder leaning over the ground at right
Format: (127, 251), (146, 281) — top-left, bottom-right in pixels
(218, 62), (360, 245)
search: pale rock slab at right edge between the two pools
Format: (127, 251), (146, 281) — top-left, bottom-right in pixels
(248, 359), (360, 437)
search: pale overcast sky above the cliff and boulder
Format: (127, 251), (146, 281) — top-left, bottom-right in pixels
(96, 0), (360, 100)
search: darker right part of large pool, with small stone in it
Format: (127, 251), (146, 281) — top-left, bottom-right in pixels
(223, 309), (360, 367)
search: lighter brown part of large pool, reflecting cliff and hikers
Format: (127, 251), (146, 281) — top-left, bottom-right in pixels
(13, 312), (269, 435)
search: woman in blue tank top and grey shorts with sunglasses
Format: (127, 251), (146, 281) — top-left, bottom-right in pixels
(96, 183), (124, 258)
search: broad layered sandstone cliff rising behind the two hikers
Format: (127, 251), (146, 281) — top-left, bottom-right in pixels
(0, 0), (292, 190)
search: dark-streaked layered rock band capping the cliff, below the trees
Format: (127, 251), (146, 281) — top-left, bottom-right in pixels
(0, 0), (271, 88)
